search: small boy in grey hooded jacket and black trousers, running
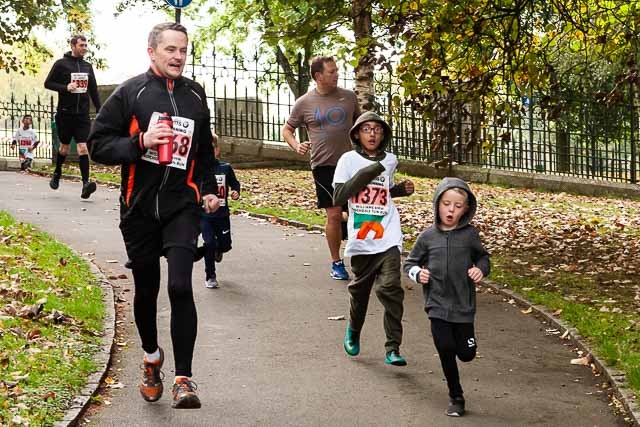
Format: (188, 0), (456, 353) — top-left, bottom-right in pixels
(404, 178), (490, 417)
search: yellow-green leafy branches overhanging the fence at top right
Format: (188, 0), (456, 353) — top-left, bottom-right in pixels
(378, 0), (640, 159)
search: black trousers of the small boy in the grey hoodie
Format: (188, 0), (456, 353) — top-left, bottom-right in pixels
(430, 318), (477, 397)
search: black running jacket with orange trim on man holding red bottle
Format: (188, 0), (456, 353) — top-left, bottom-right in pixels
(87, 70), (217, 221)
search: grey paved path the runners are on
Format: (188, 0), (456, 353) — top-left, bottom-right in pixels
(0, 172), (624, 427)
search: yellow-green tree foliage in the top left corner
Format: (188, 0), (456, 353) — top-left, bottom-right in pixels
(0, 0), (101, 74)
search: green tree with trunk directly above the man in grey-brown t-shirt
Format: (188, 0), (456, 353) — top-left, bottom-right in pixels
(119, 0), (376, 110)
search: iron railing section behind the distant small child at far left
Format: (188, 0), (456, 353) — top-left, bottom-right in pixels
(0, 94), (55, 159)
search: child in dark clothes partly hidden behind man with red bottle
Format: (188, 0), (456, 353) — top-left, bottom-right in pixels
(198, 134), (240, 289)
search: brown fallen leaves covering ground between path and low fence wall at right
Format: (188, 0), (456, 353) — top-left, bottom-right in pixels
(236, 169), (640, 316)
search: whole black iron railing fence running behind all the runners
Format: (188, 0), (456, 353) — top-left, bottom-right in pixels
(0, 47), (640, 183)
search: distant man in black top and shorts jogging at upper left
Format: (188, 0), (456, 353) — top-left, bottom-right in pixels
(44, 35), (100, 199)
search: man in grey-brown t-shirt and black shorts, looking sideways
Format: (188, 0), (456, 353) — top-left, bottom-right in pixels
(282, 56), (360, 280)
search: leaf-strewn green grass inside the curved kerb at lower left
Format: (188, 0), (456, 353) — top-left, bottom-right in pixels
(0, 212), (104, 425)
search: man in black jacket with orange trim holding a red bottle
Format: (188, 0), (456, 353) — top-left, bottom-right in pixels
(89, 23), (219, 408)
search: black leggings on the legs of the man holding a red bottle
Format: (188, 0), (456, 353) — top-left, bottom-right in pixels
(132, 247), (198, 377)
